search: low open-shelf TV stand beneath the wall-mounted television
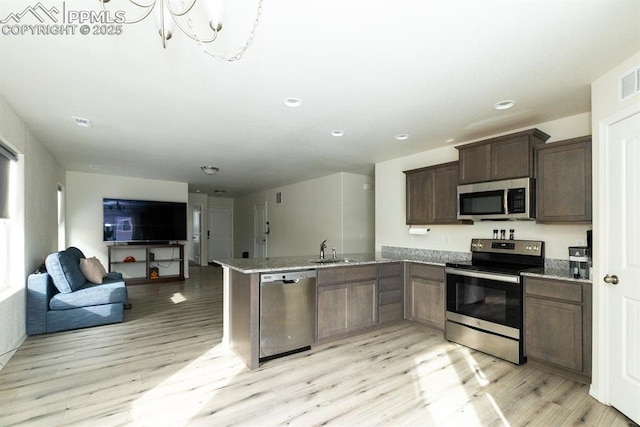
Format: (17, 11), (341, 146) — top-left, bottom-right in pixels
(108, 243), (184, 285)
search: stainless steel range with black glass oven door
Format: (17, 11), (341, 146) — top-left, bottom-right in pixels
(445, 239), (544, 364)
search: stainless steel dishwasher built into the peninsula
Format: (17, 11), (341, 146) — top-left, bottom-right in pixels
(260, 270), (316, 361)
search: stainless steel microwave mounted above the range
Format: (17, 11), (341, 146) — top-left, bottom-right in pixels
(458, 178), (536, 221)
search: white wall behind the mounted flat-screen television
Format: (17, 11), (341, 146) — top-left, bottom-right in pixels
(66, 171), (189, 275)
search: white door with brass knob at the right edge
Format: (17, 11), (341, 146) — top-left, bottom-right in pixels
(596, 108), (640, 423)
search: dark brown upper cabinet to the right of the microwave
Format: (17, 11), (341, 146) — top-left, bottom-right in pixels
(535, 136), (592, 223)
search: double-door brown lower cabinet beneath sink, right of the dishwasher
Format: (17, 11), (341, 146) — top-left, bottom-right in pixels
(316, 265), (378, 341)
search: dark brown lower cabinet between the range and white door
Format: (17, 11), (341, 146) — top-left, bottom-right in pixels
(524, 277), (591, 384)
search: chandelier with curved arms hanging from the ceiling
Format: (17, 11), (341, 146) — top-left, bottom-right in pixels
(98, 0), (263, 61)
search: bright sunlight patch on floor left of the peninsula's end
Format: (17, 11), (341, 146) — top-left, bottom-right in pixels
(131, 344), (245, 427)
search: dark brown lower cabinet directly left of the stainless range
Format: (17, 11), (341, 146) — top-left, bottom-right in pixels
(405, 263), (445, 333)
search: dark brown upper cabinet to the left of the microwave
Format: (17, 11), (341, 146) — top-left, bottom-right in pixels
(404, 162), (460, 225)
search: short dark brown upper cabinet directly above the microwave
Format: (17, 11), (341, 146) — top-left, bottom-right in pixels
(456, 129), (549, 184)
